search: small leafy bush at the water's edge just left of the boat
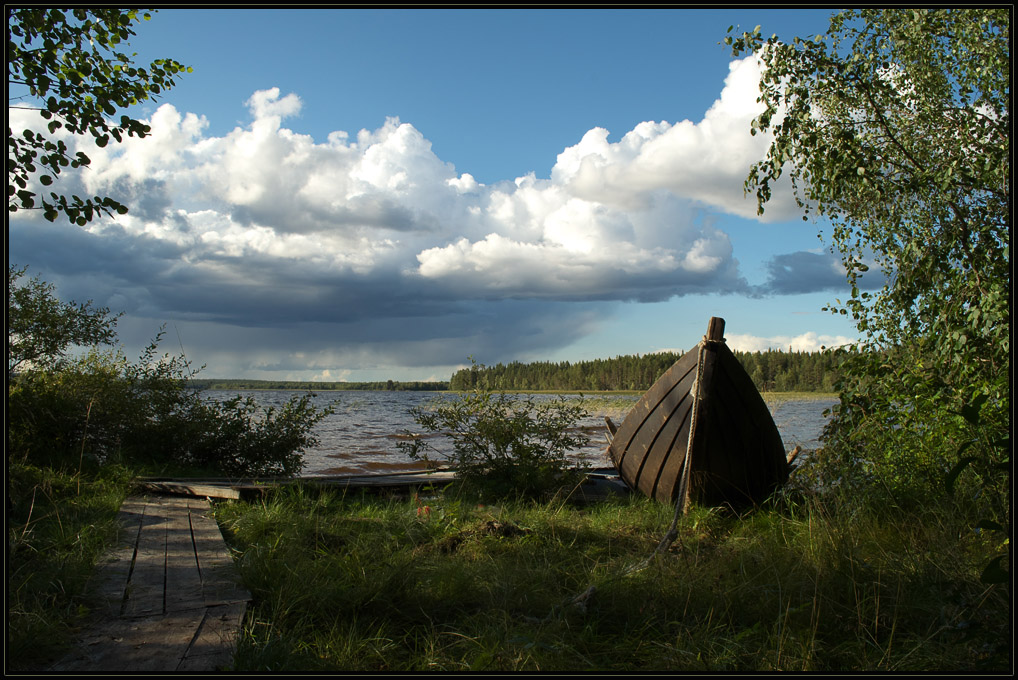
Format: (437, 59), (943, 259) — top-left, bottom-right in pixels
(398, 376), (586, 497)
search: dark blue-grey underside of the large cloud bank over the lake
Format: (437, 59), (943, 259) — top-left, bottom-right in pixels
(9, 209), (747, 342)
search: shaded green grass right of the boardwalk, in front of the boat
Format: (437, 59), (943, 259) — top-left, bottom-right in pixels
(217, 480), (1010, 672)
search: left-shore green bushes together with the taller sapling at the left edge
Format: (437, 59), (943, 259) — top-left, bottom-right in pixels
(7, 269), (330, 475)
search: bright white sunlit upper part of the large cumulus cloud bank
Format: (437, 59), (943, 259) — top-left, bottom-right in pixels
(15, 67), (773, 299)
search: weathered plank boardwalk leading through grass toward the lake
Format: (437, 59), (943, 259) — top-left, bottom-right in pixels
(51, 495), (250, 673)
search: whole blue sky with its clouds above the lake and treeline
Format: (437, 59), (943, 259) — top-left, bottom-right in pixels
(8, 8), (875, 381)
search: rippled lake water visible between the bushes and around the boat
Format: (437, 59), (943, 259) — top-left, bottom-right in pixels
(205, 390), (837, 476)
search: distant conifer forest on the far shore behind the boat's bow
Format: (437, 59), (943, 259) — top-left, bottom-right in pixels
(449, 350), (837, 392)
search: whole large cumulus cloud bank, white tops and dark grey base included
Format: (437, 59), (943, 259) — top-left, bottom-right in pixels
(9, 59), (818, 375)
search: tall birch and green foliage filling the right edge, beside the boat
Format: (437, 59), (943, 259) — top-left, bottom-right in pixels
(726, 8), (1011, 527)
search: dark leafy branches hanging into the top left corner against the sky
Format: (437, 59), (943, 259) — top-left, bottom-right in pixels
(7, 7), (191, 225)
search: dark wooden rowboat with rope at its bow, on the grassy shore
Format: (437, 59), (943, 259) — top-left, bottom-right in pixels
(608, 317), (789, 508)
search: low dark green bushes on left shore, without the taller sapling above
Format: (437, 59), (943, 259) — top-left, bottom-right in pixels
(7, 338), (329, 476)
